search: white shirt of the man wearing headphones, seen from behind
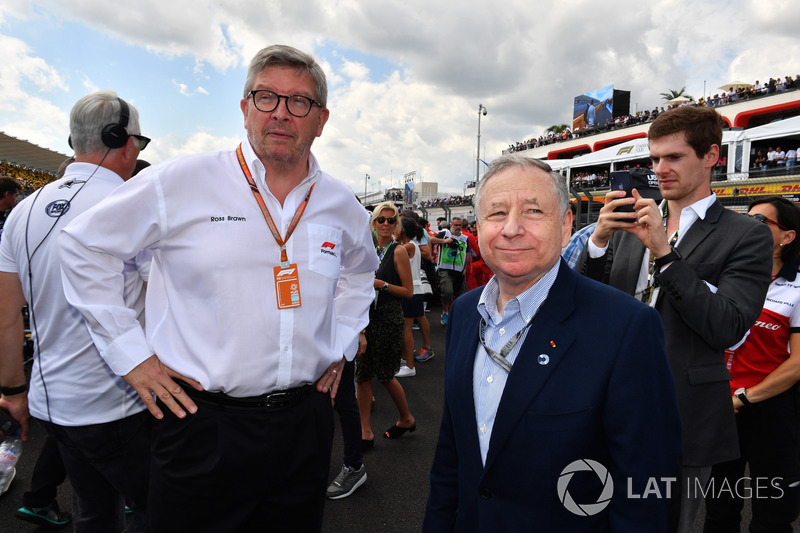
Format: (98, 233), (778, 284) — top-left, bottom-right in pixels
(0, 163), (150, 426)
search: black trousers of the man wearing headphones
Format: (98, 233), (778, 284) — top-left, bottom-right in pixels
(42, 411), (153, 533)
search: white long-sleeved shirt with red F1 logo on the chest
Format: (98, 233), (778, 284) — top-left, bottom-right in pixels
(60, 140), (378, 397)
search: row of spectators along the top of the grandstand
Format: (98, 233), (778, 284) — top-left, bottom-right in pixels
(508, 74), (800, 152)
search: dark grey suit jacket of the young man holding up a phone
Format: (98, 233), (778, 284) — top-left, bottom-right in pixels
(576, 201), (772, 466)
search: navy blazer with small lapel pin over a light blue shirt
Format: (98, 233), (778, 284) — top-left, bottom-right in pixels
(423, 261), (680, 533)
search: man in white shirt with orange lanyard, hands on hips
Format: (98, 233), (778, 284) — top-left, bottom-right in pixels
(60, 46), (378, 532)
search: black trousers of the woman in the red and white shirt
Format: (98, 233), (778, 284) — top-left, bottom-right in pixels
(703, 387), (800, 533)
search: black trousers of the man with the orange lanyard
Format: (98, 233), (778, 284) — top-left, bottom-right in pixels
(148, 389), (334, 533)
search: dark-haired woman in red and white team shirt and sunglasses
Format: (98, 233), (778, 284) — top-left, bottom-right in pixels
(704, 197), (800, 532)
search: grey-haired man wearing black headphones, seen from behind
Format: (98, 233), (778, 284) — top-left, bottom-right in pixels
(0, 91), (151, 532)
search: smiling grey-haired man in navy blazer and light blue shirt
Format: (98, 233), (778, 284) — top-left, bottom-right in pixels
(423, 155), (680, 533)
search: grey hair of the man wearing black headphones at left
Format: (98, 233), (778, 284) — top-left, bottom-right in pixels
(69, 90), (141, 154)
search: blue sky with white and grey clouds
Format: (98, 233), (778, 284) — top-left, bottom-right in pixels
(0, 0), (800, 193)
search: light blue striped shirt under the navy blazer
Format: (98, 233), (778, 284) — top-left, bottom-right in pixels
(472, 260), (561, 464)
